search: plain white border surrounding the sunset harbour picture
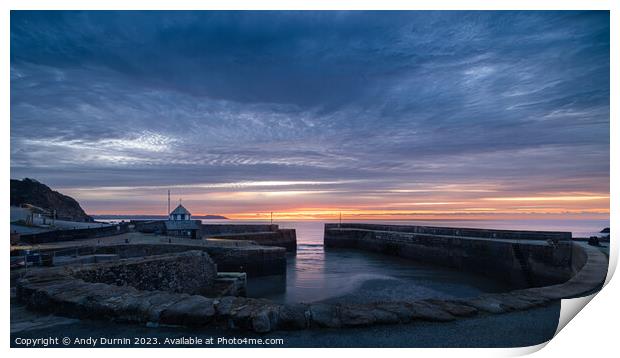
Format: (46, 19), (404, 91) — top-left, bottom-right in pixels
(0, 0), (620, 357)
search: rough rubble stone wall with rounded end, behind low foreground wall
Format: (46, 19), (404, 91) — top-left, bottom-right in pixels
(65, 250), (217, 294)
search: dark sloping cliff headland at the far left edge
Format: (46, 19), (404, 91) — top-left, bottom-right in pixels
(11, 178), (93, 221)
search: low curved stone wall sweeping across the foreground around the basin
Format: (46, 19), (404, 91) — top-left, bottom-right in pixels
(16, 245), (607, 333)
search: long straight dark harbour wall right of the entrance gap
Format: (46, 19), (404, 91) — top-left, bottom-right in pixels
(324, 224), (575, 288)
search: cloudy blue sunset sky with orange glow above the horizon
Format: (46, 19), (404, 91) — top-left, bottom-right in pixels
(10, 11), (610, 219)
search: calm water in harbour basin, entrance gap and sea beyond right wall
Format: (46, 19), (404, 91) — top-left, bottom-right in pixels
(240, 220), (609, 302)
